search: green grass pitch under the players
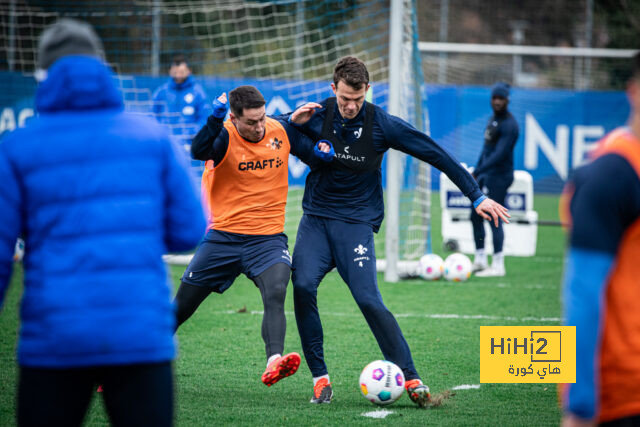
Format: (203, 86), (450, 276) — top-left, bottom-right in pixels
(0, 196), (565, 426)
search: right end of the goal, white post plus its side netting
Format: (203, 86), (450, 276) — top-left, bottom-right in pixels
(384, 0), (431, 282)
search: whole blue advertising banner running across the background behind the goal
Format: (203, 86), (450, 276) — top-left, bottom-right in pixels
(0, 72), (630, 193)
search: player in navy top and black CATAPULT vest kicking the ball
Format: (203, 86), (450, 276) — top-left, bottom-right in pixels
(289, 57), (508, 407)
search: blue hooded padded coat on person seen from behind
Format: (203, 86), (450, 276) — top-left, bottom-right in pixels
(0, 56), (205, 368)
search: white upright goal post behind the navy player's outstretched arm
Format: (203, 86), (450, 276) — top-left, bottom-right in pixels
(384, 0), (404, 282)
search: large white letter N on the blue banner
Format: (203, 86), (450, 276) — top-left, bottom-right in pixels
(524, 113), (569, 180)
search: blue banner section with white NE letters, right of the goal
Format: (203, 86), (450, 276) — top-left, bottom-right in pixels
(427, 86), (630, 193)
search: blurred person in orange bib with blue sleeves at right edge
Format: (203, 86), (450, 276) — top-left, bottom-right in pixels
(562, 53), (640, 426)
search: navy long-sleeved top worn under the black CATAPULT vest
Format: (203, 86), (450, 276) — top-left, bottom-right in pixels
(290, 99), (483, 232)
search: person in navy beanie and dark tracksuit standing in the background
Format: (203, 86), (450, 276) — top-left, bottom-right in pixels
(471, 82), (518, 277)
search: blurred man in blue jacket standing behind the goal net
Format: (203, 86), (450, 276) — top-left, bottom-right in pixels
(153, 55), (213, 152)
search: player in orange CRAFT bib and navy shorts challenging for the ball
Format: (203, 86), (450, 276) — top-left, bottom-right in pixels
(175, 86), (333, 386)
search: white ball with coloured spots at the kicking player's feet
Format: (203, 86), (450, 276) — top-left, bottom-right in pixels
(360, 360), (404, 406)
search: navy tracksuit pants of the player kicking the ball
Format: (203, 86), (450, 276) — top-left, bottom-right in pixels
(292, 214), (420, 380)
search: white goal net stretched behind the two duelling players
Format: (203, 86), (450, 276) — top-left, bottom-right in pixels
(0, 0), (430, 274)
